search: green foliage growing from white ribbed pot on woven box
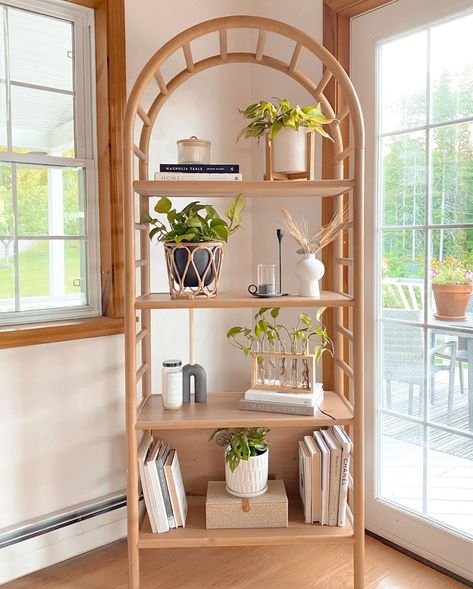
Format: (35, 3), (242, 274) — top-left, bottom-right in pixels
(209, 427), (269, 472)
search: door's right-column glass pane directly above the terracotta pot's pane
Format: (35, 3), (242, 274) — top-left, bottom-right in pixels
(431, 121), (473, 224)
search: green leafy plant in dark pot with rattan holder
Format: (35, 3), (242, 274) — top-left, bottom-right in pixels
(141, 194), (245, 298)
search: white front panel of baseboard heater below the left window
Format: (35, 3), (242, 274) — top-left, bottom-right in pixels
(0, 507), (126, 585)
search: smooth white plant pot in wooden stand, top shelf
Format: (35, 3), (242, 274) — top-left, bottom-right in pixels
(273, 127), (307, 174)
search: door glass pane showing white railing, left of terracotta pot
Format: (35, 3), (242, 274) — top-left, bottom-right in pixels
(381, 231), (425, 321)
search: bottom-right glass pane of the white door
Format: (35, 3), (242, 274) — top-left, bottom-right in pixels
(427, 428), (473, 536)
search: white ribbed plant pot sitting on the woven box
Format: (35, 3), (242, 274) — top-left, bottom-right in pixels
(225, 450), (269, 497)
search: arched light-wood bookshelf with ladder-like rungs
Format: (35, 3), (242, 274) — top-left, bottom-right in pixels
(123, 16), (364, 589)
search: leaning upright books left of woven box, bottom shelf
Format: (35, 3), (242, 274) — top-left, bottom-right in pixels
(138, 432), (187, 533)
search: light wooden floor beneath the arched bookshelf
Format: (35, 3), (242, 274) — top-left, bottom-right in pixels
(2, 538), (465, 589)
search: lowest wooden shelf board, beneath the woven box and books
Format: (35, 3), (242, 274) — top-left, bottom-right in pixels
(138, 497), (354, 548)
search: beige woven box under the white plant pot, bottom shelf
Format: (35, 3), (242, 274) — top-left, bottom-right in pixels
(205, 481), (287, 530)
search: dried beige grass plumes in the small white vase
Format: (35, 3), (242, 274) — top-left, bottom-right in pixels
(281, 206), (350, 254)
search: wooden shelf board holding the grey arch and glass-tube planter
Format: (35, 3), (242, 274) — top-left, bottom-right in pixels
(136, 391), (353, 430)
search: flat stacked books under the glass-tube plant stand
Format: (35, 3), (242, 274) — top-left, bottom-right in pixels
(240, 383), (324, 416)
